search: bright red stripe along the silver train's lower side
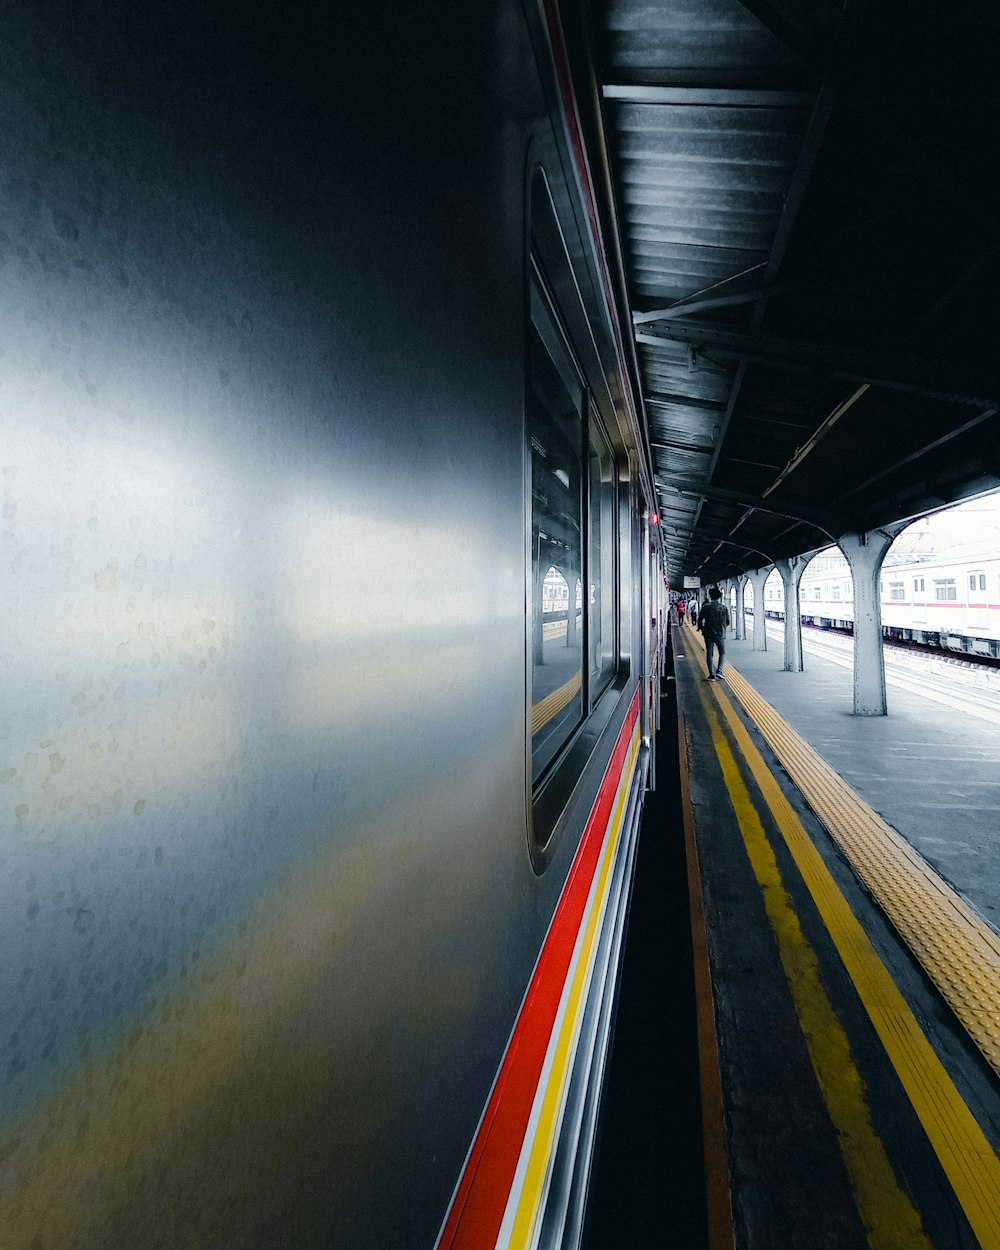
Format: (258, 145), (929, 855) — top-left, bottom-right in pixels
(438, 690), (639, 1250)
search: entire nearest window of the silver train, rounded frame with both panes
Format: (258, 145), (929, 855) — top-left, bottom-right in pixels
(524, 166), (620, 873)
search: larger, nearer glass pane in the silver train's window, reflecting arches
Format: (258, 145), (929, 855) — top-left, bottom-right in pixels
(526, 298), (585, 784)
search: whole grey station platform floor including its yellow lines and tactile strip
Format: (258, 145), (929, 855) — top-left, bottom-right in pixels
(663, 626), (1000, 1250)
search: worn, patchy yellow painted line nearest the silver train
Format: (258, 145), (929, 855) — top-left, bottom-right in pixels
(699, 675), (933, 1250)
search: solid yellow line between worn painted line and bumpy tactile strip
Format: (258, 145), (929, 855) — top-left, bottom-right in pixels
(703, 666), (1000, 1250)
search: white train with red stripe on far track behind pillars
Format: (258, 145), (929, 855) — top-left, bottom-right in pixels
(765, 545), (1000, 659)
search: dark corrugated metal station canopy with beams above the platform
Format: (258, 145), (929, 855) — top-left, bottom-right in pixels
(577, 0), (1000, 586)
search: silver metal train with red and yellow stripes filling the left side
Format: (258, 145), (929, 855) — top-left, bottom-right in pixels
(0, 0), (664, 1250)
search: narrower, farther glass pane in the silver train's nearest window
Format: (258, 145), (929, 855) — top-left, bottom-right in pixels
(588, 416), (615, 708)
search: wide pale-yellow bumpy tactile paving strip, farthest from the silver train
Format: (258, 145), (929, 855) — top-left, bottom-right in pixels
(725, 665), (1000, 1075)
